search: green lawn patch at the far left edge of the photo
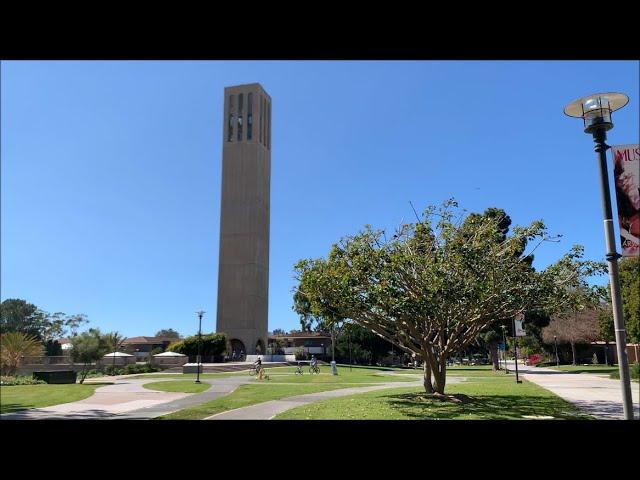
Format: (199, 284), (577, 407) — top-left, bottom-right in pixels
(0, 383), (107, 413)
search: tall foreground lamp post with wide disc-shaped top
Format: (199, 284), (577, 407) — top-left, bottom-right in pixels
(564, 92), (633, 420)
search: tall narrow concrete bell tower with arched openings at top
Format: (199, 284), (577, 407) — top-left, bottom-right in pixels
(216, 83), (271, 354)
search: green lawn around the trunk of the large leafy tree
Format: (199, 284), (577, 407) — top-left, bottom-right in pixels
(276, 376), (590, 420)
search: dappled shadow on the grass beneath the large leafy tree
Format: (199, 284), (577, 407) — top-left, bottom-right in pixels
(387, 393), (584, 420)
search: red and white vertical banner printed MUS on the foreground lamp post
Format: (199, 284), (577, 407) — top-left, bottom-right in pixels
(611, 145), (640, 257)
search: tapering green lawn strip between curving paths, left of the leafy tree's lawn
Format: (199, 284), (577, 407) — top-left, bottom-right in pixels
(159, 382), (358, 420)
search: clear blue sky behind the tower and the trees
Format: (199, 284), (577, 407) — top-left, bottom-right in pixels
(1, 61), (640, 336)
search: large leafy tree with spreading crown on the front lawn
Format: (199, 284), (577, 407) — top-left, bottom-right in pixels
(295, 200), (604, 394)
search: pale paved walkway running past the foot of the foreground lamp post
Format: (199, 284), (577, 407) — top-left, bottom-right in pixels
(508, 361), (640, 420)
